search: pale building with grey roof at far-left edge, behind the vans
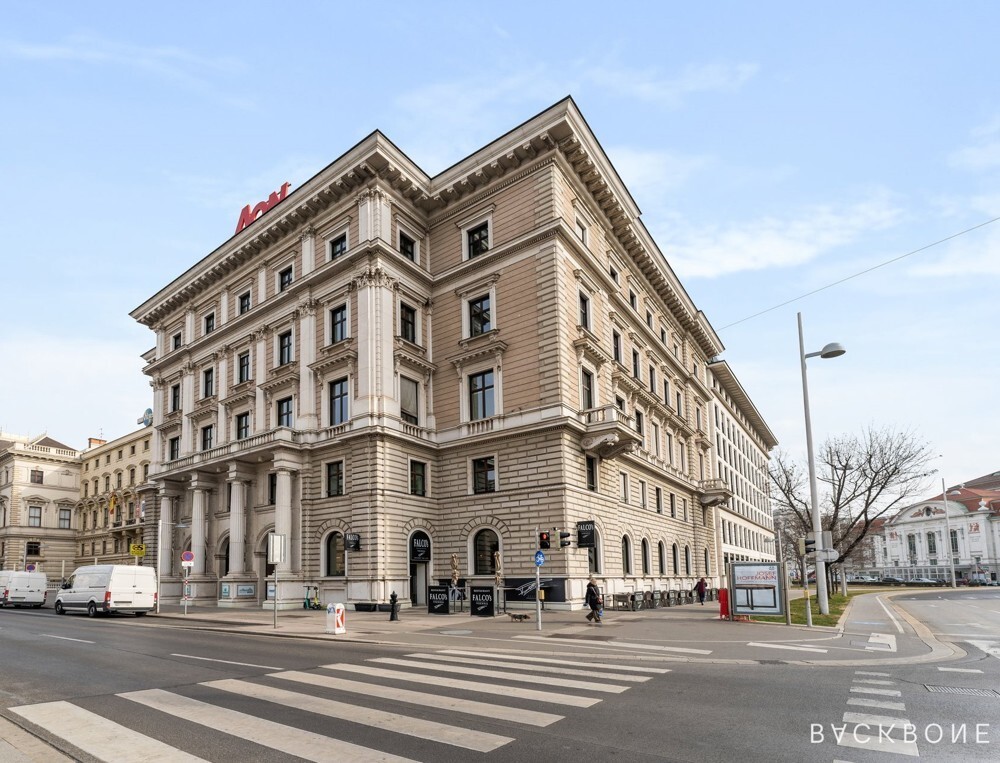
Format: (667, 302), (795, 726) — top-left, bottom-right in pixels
(0, 432), (80, 581)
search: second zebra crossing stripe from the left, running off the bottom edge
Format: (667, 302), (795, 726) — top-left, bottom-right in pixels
(123, 689), (412, 763)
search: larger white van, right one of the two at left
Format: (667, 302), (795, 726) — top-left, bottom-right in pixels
(55, 564), (156, 617)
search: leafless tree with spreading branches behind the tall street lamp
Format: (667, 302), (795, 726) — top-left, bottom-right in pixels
(769, 428), (936, 580)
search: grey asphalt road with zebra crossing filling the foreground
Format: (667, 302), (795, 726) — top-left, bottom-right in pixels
(0, 591), (1000, 763)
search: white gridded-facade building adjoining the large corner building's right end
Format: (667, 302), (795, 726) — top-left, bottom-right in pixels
(709, 360), (778, 570)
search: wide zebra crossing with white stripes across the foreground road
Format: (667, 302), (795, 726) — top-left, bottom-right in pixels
(9, 649), (670, 763)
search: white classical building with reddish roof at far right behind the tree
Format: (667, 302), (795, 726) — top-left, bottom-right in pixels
(876, 475), (1000, 582)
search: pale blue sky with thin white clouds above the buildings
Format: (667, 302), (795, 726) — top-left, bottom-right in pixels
(0, 0), (1000, 484)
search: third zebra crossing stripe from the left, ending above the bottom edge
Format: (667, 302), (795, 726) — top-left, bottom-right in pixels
(206, 678), (514, 752)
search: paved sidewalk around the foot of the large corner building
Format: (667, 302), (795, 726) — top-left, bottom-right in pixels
(146, 593), (962, 665)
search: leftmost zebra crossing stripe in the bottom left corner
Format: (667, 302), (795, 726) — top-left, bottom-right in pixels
(10, 702), (204, 763)
